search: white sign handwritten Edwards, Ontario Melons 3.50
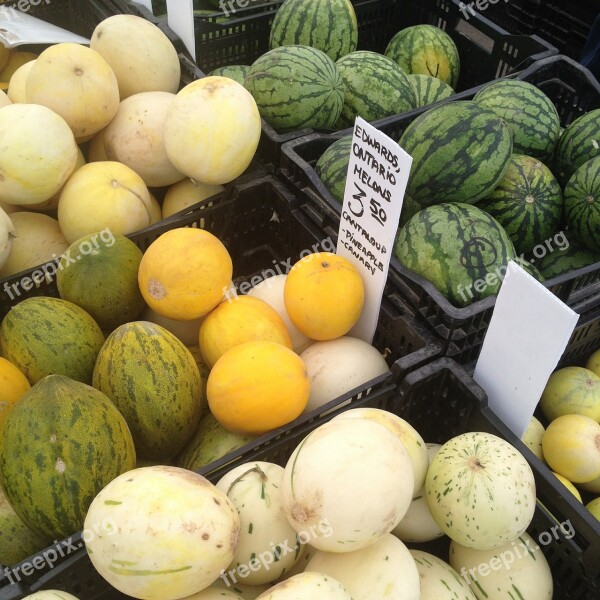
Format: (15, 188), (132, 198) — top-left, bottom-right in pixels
(337, 117), (412, 343)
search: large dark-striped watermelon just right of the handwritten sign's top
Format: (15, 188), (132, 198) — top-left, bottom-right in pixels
(400, 101), (512, 206)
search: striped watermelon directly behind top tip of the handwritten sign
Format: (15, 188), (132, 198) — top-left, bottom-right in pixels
(336, 50), (416, 129)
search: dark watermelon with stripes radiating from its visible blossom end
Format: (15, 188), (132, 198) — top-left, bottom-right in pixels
(477, 154), (563, 254)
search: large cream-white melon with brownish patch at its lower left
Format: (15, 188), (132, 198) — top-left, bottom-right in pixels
(283, 419), (413, 552)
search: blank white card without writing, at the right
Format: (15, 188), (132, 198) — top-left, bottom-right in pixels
(473, 261), (579, 438)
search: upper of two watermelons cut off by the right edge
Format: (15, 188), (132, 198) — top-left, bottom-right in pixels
(553, 108), (600, 188)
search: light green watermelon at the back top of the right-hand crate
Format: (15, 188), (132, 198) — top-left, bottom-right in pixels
(473, 79), (560, 161)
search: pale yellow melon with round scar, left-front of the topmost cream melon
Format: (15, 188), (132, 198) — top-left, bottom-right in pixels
(25, 42), (119, 139)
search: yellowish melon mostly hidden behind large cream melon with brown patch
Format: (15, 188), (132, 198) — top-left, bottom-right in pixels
(332, 408), (429, 497)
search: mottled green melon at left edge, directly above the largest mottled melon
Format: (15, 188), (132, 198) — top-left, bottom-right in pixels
(0, 296), (104, 385)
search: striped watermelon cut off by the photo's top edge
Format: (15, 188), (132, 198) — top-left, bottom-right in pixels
(269, 0), (358, 61)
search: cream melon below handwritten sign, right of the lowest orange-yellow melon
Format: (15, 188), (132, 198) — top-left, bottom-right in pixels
(300, 335), (389, 413)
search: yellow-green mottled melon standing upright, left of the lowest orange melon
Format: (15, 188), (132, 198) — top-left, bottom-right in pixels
(92, 321), (203, 461)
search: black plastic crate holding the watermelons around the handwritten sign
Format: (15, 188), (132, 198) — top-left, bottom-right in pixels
(279, 56), (600, 364)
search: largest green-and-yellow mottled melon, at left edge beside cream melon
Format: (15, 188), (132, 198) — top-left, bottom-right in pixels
(0, 375), (136, 539)
